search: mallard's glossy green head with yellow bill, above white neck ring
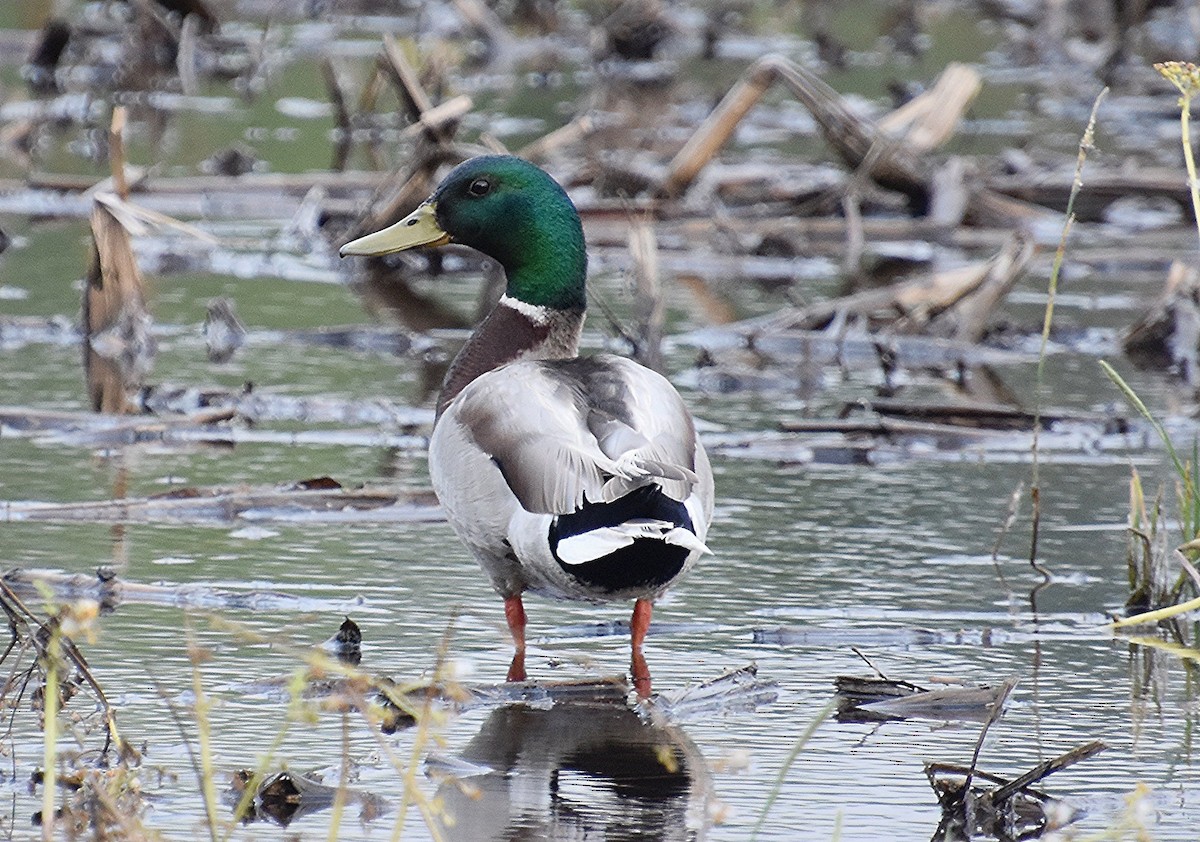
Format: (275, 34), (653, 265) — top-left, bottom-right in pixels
(341, 155), (588, 309)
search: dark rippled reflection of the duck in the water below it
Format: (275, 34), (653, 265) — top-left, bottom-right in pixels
(438, 703), (715, 842)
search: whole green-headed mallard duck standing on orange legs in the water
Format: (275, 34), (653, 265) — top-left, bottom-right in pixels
(341, 156), (713, 696)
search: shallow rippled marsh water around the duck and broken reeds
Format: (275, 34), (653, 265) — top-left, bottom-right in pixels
(0, 0), (1200, 840)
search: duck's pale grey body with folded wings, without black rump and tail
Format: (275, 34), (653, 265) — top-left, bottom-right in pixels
(430, 355), (713, 595)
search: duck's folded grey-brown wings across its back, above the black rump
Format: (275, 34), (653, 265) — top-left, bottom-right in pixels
(439, 355), (697, 515)
